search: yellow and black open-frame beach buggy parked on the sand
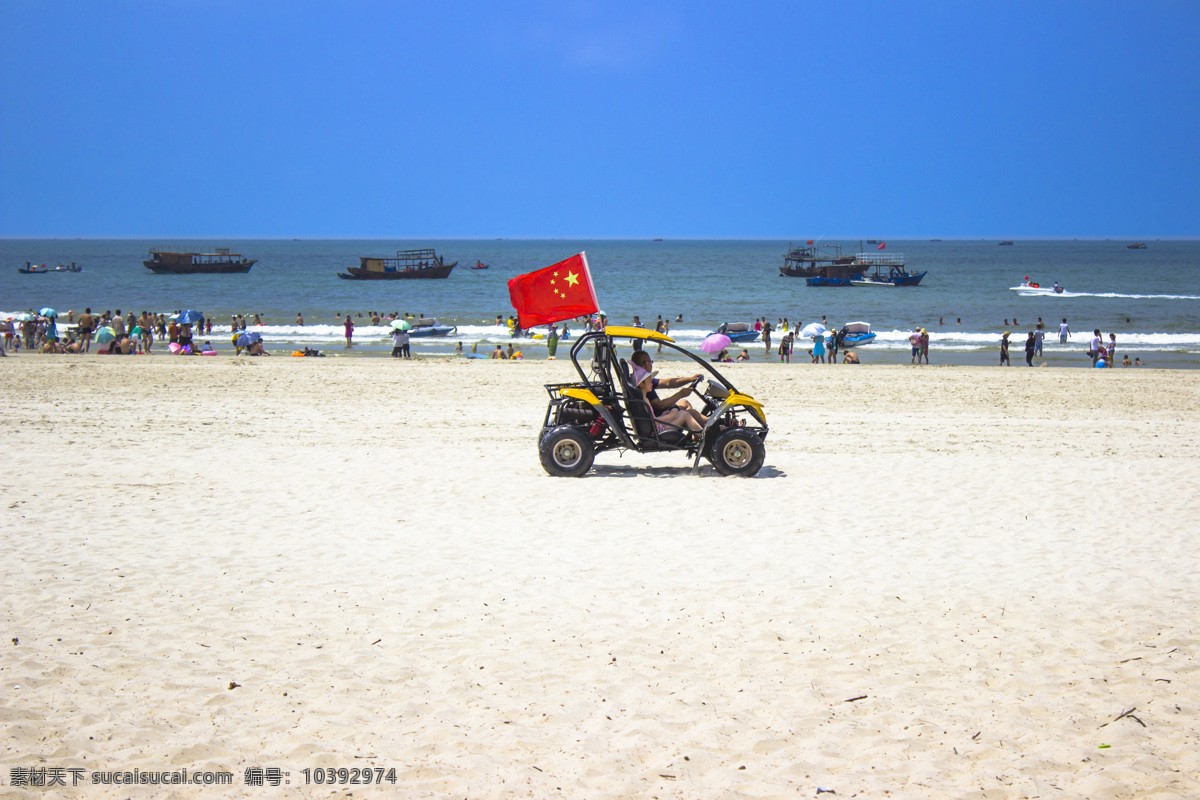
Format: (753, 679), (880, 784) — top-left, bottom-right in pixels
(538, 326), (767, 477)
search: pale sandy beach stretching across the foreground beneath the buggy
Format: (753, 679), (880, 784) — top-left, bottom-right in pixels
(0, 354), (1200, 800)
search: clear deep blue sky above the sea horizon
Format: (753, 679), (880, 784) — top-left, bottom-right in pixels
(0, 0), (1200, 239)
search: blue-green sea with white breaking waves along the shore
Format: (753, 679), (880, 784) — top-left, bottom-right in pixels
(0, 239), (1200, 367)
